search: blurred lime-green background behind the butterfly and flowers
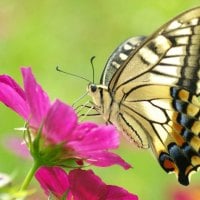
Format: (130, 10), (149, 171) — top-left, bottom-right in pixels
(0, 0), (200, 200)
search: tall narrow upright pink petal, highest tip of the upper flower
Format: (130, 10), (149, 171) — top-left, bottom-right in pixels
(21, 68), (50, 127)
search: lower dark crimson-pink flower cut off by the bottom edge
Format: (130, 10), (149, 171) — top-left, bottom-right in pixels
(36, 167), (138, 200)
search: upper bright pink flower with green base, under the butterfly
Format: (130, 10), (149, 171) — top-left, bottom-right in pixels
(0, 68), (131, 169)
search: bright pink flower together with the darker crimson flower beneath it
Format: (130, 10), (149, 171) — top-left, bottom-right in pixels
(0, 68), (137, 200)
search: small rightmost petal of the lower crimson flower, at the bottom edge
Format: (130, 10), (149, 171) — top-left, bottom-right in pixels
(106, 185), (138, 200)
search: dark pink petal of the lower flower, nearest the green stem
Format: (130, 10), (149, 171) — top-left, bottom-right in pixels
(35, 167), (69, 198)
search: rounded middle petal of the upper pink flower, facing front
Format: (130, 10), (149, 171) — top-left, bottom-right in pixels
(44, 100), (77, 143)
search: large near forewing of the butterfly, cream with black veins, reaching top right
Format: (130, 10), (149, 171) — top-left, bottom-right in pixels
(109, 8), (200, 90)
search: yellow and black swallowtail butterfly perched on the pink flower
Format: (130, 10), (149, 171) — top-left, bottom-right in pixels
(87, 7), (200, 185)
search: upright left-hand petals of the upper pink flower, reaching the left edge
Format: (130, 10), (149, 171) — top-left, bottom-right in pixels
(0, 68), (50, 128)
